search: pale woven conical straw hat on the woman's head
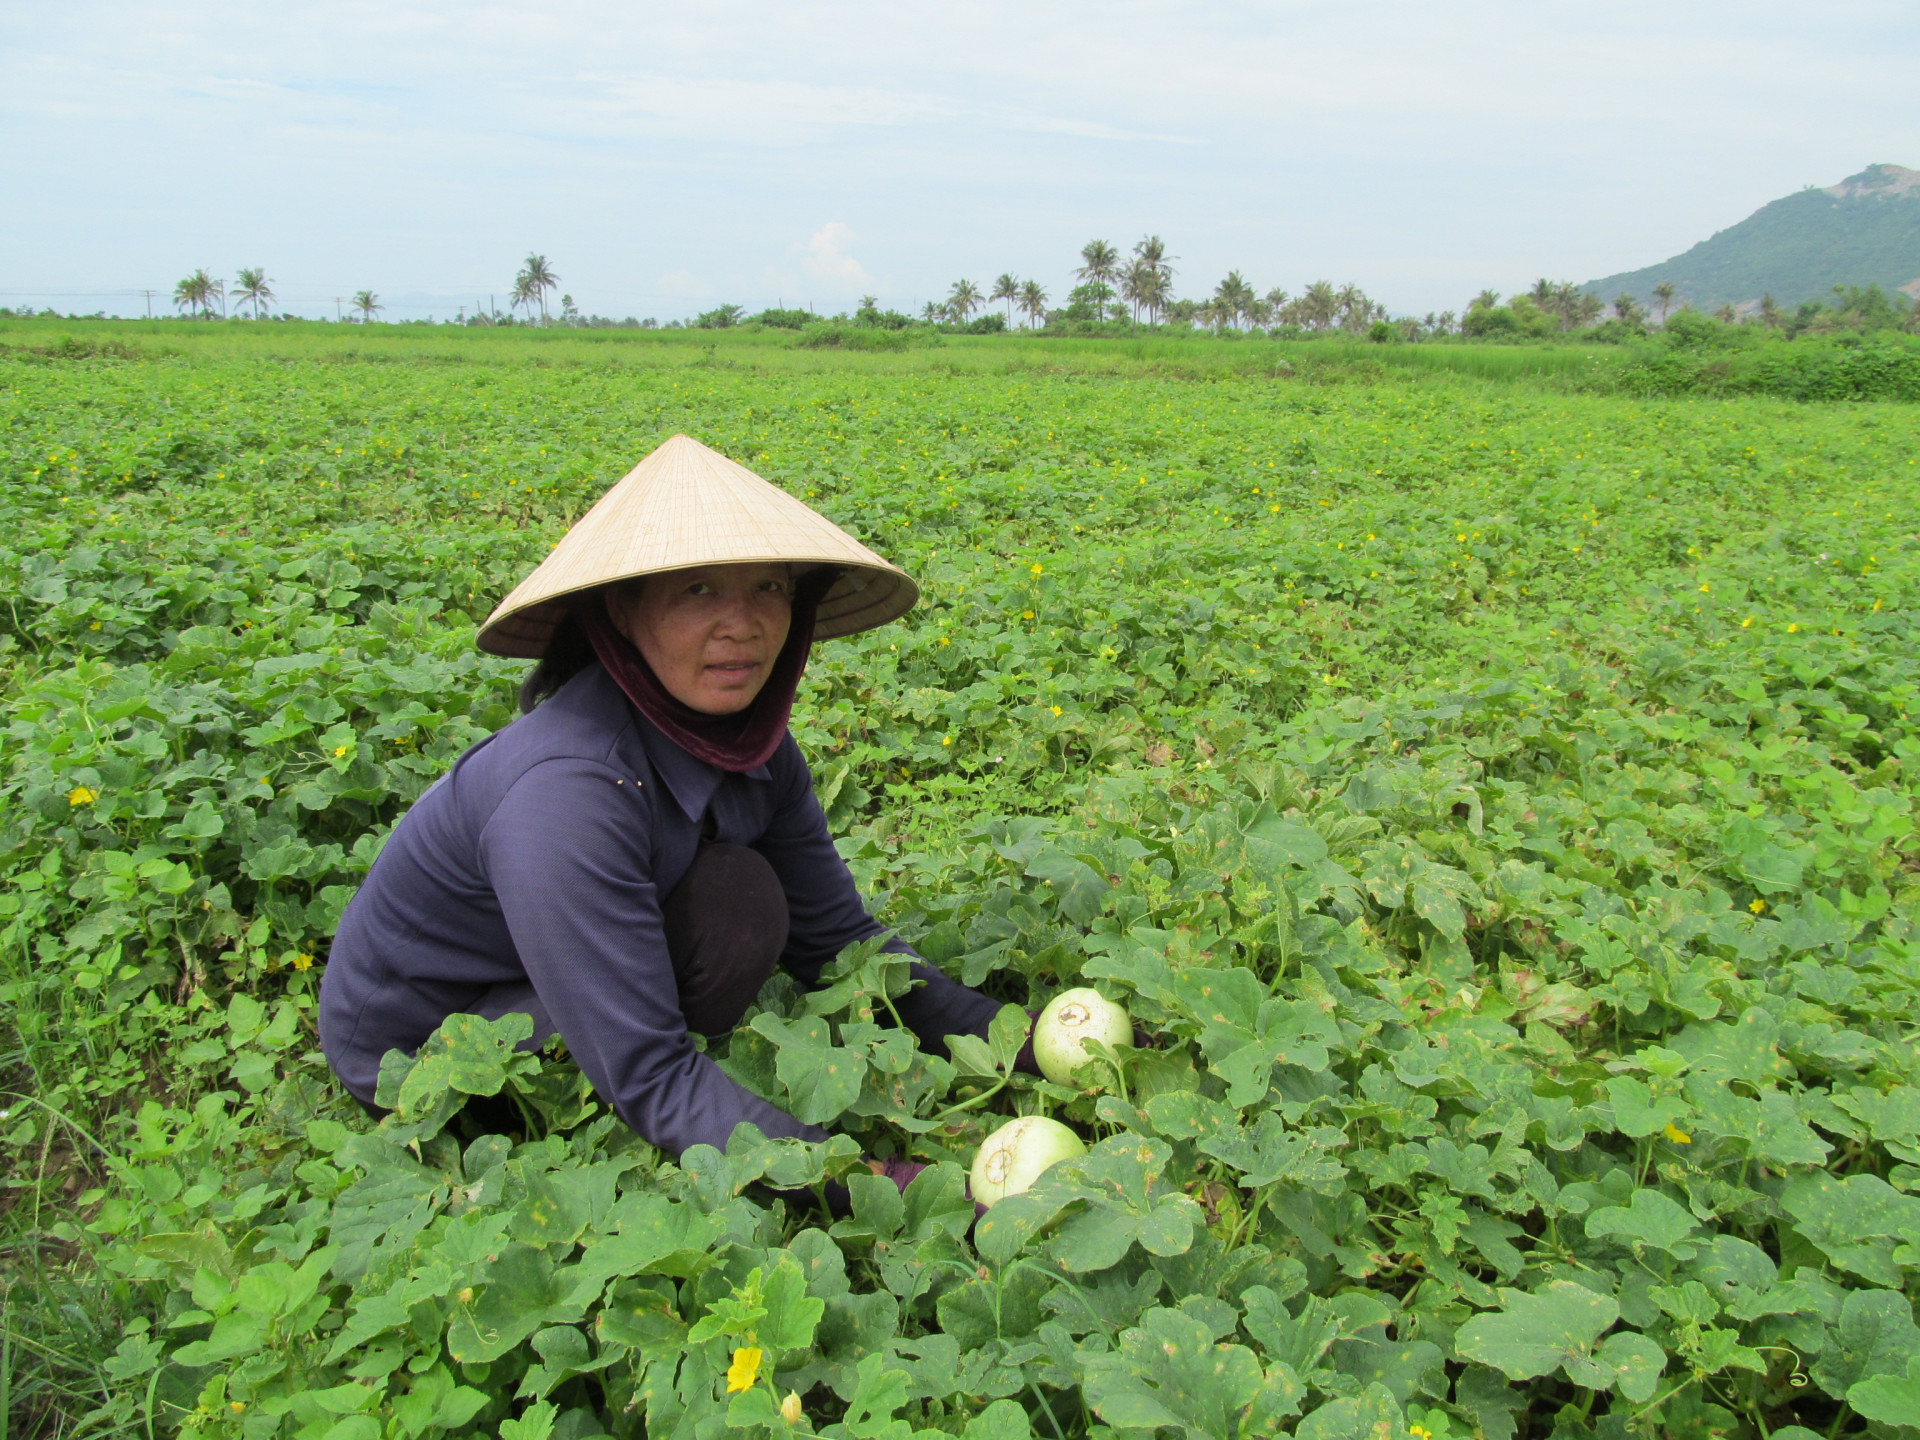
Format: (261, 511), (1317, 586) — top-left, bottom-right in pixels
(478, 436), (920, 660)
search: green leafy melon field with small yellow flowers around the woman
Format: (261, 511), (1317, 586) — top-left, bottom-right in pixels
(0, 323), (1920, 1440)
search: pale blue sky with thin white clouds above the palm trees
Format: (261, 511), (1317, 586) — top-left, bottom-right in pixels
(0, 0), (1920, 319)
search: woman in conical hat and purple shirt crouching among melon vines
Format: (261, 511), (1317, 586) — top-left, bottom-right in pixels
(321, 436), (1031, 1185)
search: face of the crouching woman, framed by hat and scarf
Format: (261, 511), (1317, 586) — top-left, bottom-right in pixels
(607, 564), (793, 714)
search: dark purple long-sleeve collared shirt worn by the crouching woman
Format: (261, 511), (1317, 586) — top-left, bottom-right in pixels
(321, 664), (998, 1154)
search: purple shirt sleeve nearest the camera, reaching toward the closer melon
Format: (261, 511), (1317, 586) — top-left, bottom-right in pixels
(480, 758), (826, 1156)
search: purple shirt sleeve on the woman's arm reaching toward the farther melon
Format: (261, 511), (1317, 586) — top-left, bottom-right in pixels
(755, 735), (1000, 1056)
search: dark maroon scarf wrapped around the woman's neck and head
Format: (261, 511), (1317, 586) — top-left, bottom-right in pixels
(576, 566), (839, 774)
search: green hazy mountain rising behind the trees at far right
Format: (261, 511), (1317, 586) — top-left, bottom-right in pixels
(1584, 165), (1920, 309)
